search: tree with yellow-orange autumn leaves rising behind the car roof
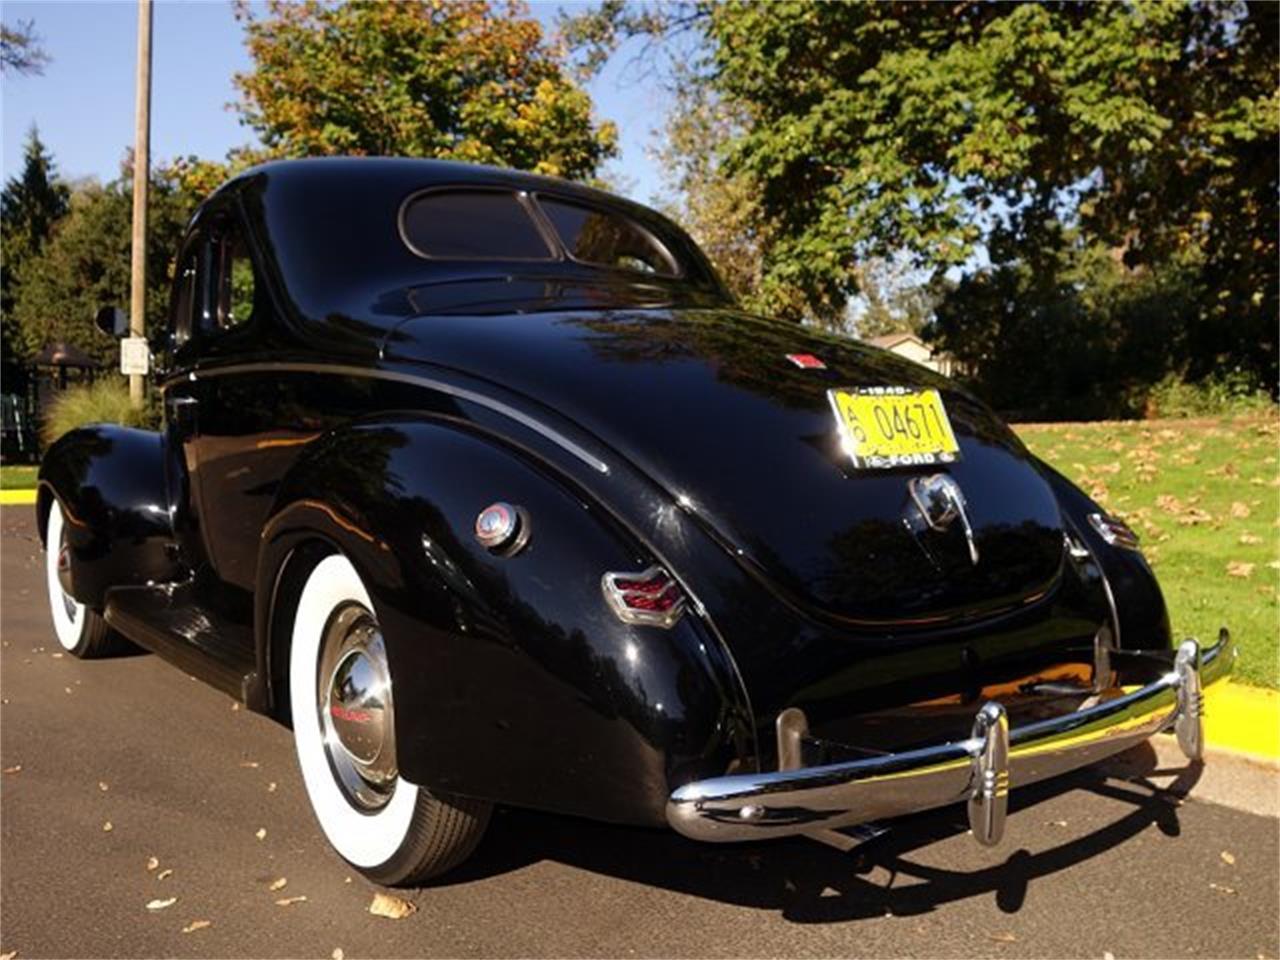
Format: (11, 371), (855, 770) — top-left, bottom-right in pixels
(236, 0), (616, 179)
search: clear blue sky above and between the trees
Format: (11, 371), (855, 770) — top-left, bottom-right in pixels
(0, 0), (667, 202)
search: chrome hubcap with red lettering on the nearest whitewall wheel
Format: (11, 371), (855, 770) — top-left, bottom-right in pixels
(317, 604), (398, 810)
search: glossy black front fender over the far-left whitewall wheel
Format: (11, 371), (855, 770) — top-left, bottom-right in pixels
(36, 424), (179, 609)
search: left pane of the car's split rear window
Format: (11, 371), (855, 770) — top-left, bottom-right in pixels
(401, 189), (552, 260)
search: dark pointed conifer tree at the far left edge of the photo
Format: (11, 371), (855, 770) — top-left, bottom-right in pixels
(0, 125), (69, 392)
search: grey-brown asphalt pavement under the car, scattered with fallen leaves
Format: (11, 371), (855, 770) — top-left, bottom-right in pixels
(0, 507), (1280, 960)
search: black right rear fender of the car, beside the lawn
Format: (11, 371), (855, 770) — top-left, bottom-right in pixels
(1037, 461), (1174, 650)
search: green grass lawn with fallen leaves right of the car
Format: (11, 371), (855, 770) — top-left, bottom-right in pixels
(1016, 416), (1280, 687)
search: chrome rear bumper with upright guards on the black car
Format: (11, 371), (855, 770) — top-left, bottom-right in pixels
(667, 630), (1235, 845)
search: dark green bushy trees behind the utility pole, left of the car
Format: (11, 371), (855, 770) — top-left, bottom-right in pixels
(13, 175), (195, 366)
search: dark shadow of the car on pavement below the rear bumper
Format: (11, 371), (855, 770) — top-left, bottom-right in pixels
(442, 744), (1203, 923)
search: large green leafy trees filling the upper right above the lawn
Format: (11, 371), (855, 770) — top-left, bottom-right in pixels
(568, 0), (1280, 412)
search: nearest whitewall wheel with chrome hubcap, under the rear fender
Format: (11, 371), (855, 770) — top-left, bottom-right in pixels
(289, 554), (492, 886)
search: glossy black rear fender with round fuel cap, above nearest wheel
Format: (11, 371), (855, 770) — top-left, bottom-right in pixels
(256, 415), (753, 826)
